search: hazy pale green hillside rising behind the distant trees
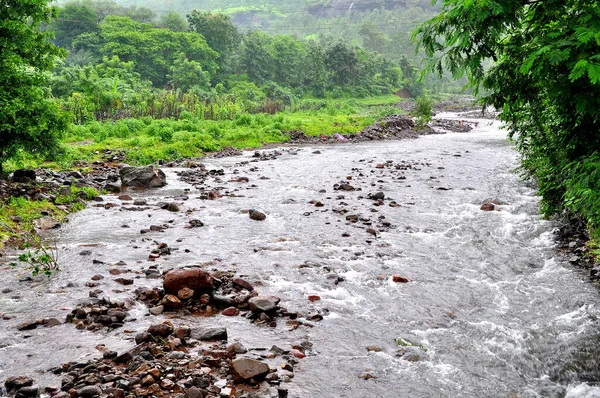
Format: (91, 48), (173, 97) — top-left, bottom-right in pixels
(58, 0), (435, 49)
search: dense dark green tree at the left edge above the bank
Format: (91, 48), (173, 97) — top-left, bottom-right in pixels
(0, 0), (66, 173)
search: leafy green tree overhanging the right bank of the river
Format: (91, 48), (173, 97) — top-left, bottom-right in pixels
(414, 0), (600, 227)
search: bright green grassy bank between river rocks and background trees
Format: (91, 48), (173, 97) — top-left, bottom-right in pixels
(8, 95), (402, 169)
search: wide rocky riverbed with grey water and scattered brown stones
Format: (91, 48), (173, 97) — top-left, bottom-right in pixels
(0, 112), (597, 398)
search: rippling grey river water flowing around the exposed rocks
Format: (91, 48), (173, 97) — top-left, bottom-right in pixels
(0, 116), (600, 398)
